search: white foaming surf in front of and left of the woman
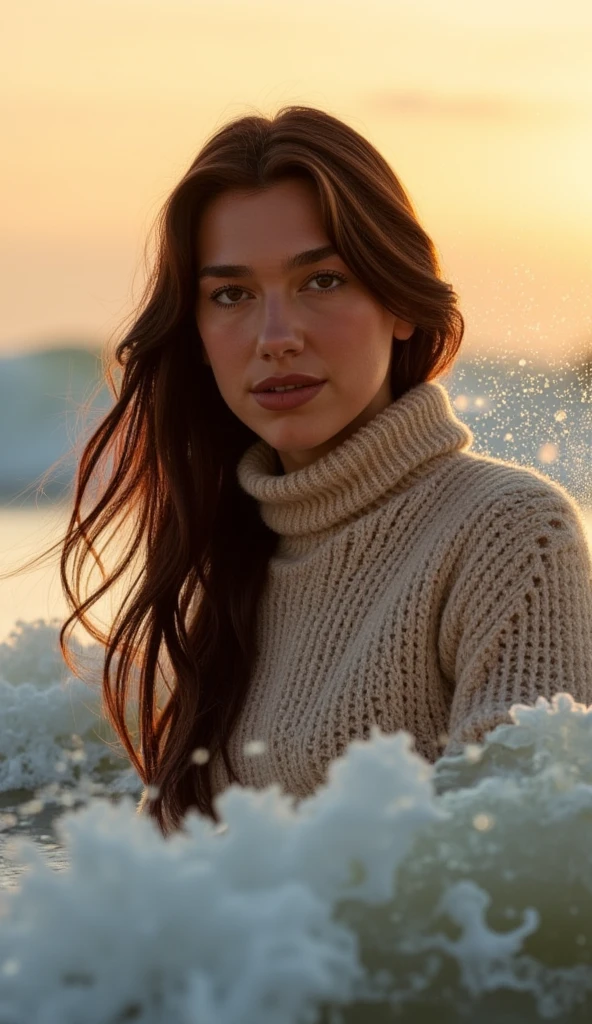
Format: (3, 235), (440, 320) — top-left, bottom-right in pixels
(0, 624), (592, 1024)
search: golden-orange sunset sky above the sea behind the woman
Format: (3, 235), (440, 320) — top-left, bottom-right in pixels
(0, 0), (592, 358)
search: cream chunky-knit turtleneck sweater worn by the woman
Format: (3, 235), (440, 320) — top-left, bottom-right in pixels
(139, 382), (592, 815)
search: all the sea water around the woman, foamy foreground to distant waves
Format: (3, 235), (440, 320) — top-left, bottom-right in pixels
(0, 353), (592, 1024)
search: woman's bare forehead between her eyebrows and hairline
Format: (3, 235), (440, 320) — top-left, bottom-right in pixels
(197, 179), (328, 263)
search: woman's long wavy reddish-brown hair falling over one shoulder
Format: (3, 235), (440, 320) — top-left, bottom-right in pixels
(21, 105), (464, 836)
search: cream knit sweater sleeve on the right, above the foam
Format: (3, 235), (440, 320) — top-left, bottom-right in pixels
(438, 480), (592, 755)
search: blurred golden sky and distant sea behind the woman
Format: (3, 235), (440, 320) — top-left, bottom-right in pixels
(0, 0), (592, 642)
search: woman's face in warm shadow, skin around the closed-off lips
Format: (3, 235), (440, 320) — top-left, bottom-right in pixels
(196, 178), (414, 473)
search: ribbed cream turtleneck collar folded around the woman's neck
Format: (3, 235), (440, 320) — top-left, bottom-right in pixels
(237, 381), (473, 537)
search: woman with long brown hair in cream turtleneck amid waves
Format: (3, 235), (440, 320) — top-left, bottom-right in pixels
(53, 106), (592, 835)
